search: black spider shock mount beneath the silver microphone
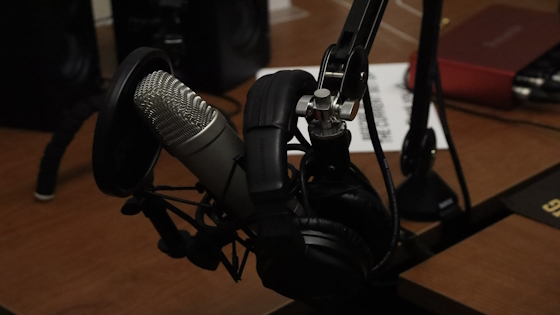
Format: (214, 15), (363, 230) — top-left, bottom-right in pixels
(121, 179), (254, 282)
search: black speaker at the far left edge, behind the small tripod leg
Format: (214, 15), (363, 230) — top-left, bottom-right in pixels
(0, 0), (100, 131)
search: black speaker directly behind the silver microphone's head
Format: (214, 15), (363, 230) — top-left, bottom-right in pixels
(112, 0), (270, 93)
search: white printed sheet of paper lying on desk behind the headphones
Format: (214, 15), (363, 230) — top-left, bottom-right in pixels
(257, 63), (448, 154)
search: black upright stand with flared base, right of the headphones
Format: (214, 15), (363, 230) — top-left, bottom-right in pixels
(396, 0), (461, 221)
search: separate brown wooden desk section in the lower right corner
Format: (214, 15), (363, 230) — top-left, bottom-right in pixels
(399, 214), (560, 315)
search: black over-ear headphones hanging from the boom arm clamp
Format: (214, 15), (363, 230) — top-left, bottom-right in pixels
(243, 70), (394, 301)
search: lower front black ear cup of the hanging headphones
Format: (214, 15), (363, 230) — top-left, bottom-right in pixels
(257, 217), (372, 301)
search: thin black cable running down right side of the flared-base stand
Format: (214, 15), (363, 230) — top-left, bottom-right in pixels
(434, 62), (471, 215)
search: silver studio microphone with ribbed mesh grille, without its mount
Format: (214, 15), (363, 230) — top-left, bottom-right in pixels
(134, 70), (254, 219)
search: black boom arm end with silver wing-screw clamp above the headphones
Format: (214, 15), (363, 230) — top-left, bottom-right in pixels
(296, 0), (388, 170)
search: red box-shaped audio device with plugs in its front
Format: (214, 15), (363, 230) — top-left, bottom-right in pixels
(409, 5), (560, 109)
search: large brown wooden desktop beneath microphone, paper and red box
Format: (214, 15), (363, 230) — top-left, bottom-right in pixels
(0, 0), (560, 315)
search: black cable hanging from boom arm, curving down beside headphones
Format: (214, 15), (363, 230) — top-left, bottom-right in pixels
(363, 87), (400, 277)
